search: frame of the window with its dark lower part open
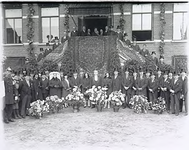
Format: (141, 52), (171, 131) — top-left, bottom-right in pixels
(131, 3), (154, 42)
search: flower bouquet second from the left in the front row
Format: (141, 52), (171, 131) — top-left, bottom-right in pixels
(46, 95), (65, 113)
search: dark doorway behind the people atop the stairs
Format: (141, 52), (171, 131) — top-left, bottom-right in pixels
(84, 16), (108, 33)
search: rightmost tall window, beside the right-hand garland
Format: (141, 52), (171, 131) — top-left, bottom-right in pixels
(173, 3), (188, 40)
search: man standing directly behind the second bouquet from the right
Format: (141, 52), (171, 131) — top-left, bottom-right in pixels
(136, 67), (148, 96)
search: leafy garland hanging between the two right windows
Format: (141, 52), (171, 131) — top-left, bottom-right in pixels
(159, 3), (166, 55)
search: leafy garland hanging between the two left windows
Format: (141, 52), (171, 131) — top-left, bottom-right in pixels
(26, 3), (37, 69)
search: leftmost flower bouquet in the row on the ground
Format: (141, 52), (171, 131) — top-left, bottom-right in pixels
(28, 100), (49, 119)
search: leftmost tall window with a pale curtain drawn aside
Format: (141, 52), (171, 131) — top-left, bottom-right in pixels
(5, 9), (22, 44)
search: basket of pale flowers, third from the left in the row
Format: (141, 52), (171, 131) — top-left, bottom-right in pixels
(66, 87), (85, 112)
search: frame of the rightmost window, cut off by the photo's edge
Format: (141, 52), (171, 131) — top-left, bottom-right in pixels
(172, 3), (189, 41)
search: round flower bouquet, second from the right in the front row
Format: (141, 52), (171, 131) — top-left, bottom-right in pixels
(129, 95), (149, 114)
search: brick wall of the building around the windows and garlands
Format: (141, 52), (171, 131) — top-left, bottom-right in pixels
(4, 3), (187, 64)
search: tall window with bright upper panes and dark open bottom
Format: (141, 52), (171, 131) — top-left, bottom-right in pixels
(132, 4), (152, 41)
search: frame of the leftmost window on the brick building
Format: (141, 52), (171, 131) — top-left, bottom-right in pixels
(3, 8), (23, 45)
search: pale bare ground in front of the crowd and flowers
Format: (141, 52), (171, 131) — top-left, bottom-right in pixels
(1, 108), (189, 150)
